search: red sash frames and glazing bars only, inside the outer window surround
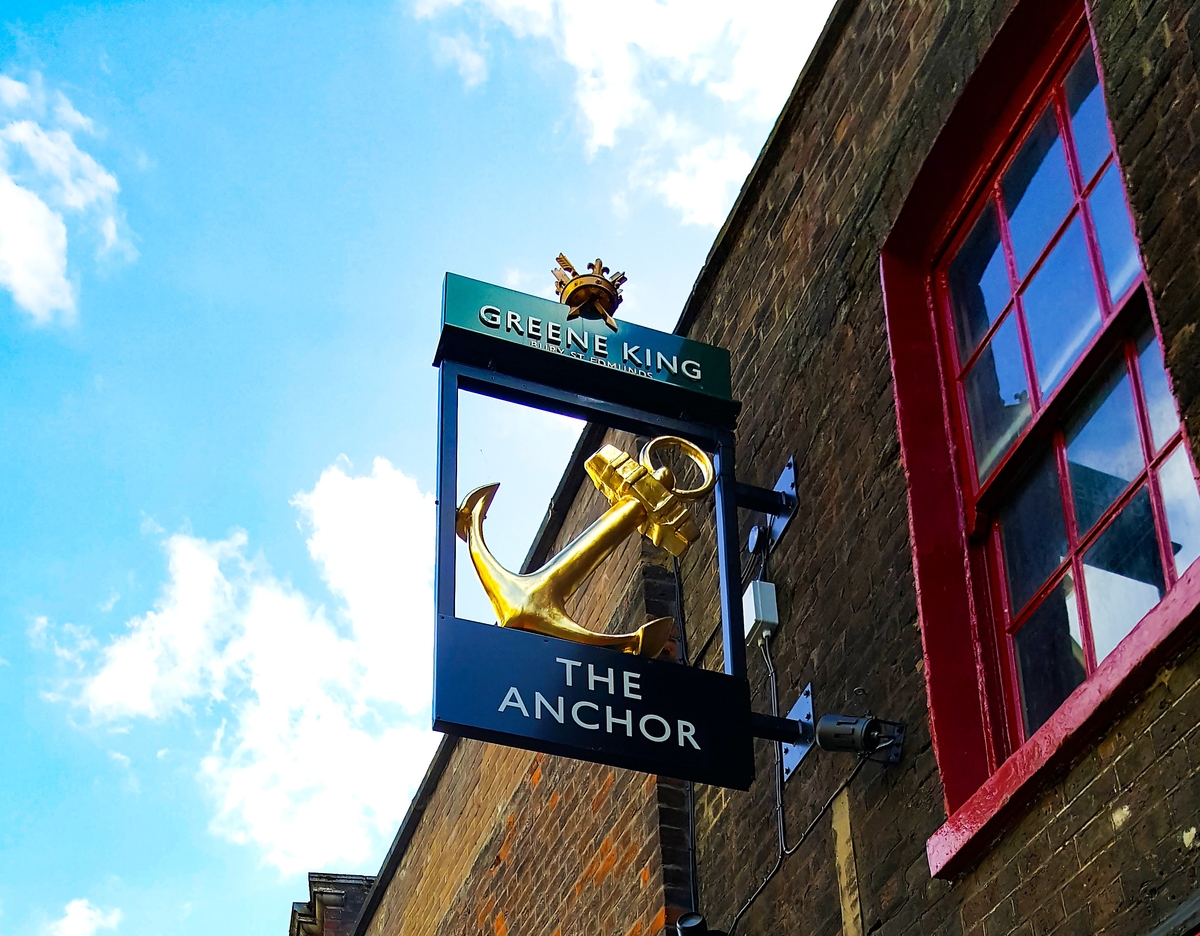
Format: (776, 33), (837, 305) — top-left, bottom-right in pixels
(932, 29), (1195, 769)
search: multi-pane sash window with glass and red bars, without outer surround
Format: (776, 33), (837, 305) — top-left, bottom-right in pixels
(935, 42), (1200, 754)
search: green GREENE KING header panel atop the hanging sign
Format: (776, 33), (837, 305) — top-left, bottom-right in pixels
(434, 274), (738, 425)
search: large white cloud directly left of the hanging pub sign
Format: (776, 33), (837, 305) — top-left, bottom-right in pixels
(56, 458), (436, 874)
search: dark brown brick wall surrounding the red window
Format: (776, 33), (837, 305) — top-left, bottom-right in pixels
(685, 0), (1200, 936)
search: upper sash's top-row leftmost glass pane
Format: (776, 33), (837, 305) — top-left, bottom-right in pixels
(949, 202), (1012, 361)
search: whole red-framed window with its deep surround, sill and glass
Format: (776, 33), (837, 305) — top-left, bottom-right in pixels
(881, 0), (1200, 876)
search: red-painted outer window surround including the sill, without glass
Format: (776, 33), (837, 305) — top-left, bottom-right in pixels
(881, 0), (1200, 876)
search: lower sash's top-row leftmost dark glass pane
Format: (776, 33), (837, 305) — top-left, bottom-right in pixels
(1000, 452), (1067, 616)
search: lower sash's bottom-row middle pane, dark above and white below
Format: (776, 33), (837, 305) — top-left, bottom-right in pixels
(1084, 487), (1166, 662)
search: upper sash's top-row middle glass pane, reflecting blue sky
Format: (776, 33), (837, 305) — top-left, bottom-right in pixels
(1003, 107), (1075, 276)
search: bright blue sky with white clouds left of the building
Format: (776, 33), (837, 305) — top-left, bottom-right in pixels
(0, 0), (829, 936)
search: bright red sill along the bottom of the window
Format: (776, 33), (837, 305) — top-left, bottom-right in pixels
(925, 562), (1200, 878)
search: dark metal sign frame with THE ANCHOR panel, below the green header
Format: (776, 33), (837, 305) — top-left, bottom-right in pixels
(433, 279), (794, 790)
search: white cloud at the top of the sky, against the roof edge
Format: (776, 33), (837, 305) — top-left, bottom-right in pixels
(414, 0), (833, 224)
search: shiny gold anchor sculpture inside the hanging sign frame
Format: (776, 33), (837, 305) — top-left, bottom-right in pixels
(455, 436), (716, 656)
